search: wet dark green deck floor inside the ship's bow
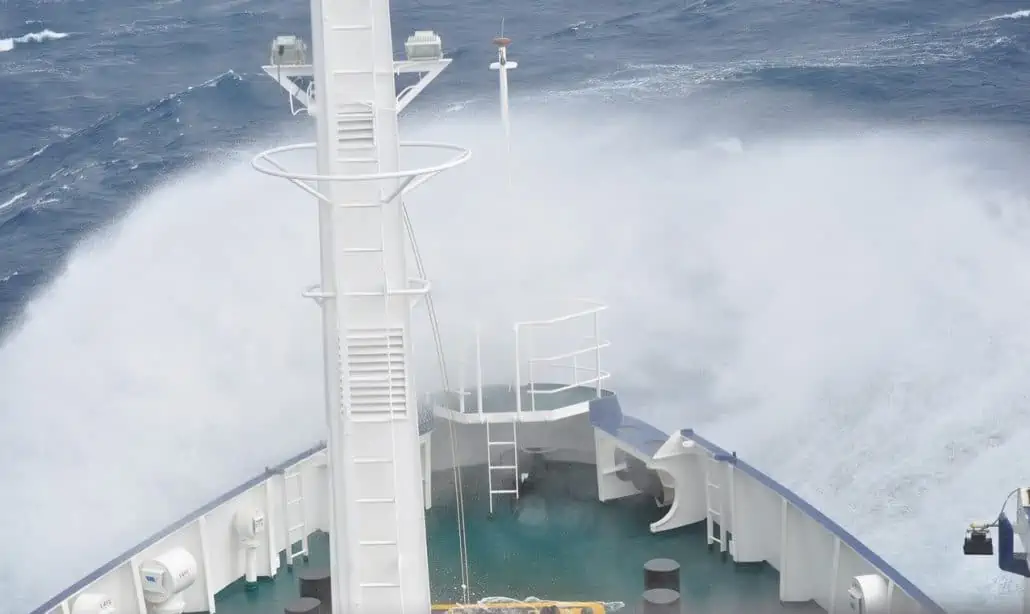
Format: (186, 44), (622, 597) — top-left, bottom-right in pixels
(216, 463), (822, 614)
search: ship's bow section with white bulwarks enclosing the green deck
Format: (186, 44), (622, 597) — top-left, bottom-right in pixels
(26, 393), (942, 614)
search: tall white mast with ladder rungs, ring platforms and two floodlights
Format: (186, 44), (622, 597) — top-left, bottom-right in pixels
(253, 0), (469, 614)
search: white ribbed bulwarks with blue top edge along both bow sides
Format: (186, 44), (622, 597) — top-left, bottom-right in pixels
(31, 412), (945, 614)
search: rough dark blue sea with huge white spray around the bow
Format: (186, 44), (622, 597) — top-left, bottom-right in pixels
(0, 0), (1030, 613)
